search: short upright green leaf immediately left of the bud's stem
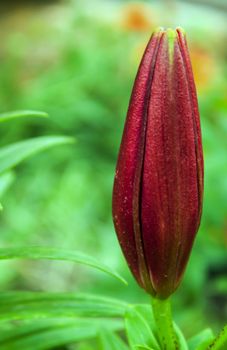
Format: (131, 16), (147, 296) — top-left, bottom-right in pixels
(125, 305), (160, 350)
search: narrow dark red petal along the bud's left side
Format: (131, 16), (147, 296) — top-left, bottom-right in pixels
(113, 31), (162, 285)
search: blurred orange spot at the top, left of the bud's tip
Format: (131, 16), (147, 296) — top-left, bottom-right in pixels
(121, 4), (152, 31)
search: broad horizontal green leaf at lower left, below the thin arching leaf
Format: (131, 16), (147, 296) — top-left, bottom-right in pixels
(0, 292), (127, 322)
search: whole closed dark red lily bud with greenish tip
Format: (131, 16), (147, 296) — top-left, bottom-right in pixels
(113, 29), (203, 298)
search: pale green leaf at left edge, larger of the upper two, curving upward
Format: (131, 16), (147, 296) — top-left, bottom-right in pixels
(0, 136), (73, 173)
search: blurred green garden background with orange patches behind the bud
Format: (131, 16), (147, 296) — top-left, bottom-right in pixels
(0, 0), (227, 336)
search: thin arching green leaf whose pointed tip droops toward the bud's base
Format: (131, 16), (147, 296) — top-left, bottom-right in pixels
(0, 247), (127, 284)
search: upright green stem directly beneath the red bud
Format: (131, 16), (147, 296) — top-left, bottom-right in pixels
(152, 298), (179, 350)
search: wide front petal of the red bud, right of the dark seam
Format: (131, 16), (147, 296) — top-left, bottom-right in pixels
(141, 31), (203, 297)
